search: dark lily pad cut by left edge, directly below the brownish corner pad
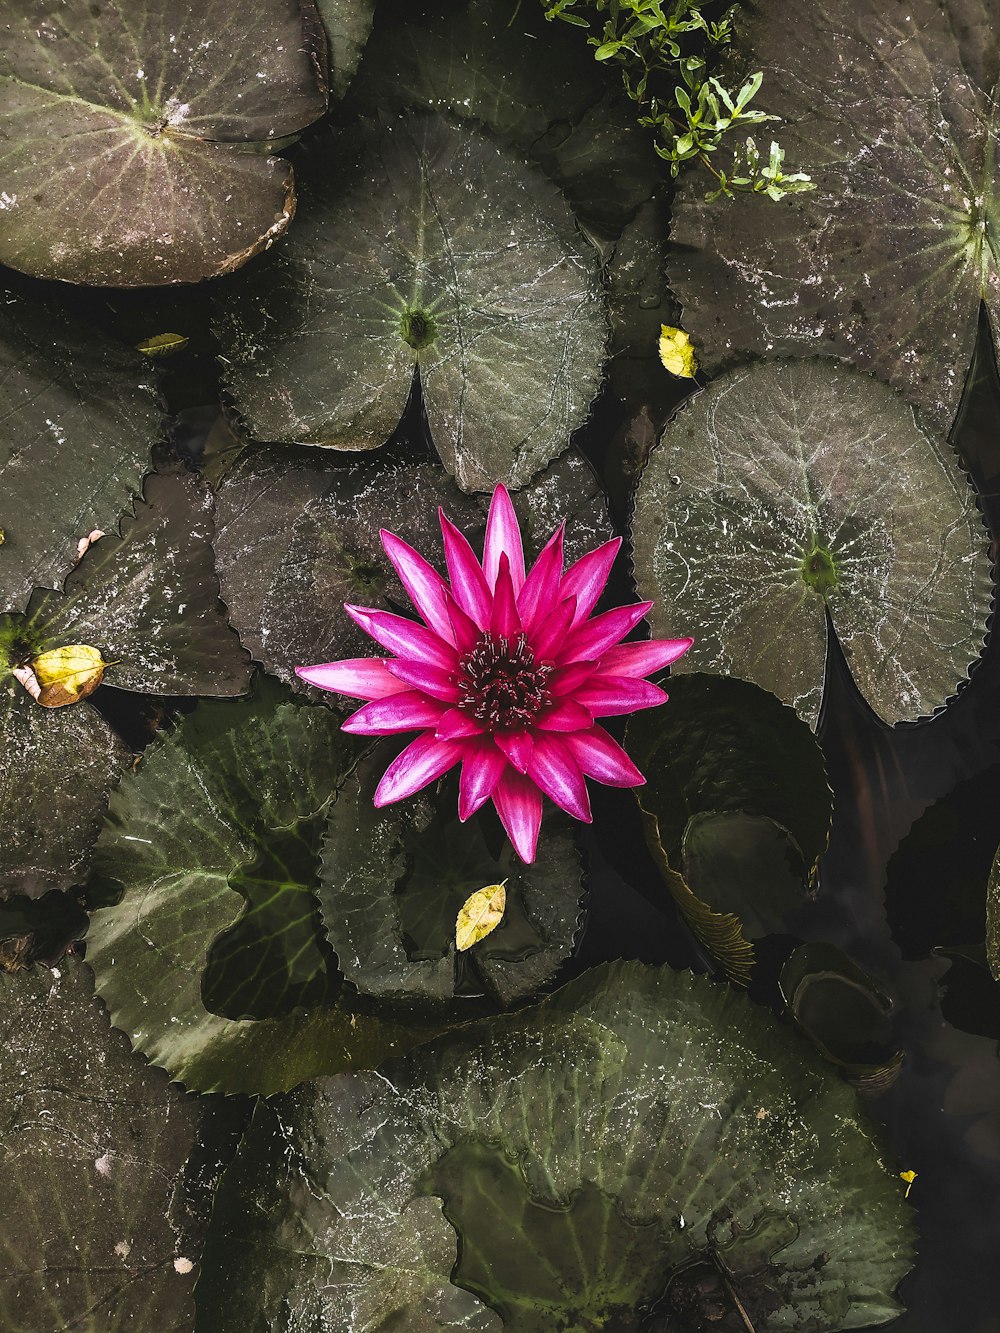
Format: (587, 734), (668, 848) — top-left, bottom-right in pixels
(0, 291), (160, 612)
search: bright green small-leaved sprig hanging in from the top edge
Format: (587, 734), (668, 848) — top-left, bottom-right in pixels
(543, 0), (815, 200)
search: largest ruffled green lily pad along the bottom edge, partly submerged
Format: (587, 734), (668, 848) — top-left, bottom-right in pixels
(199, 964), (912, 1333)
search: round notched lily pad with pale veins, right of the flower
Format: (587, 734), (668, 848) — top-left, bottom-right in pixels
(632, 360), (991, 726)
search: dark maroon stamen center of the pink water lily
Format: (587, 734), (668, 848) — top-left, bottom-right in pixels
(459, 633), (552, 732)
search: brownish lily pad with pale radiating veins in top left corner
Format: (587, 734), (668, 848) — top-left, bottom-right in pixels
(0, 0), (327, 287)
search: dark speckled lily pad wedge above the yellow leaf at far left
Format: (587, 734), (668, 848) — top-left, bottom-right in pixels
(25, 473), (249, 694)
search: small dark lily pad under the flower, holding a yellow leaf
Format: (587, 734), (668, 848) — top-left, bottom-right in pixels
(320, 770), (583, 1005)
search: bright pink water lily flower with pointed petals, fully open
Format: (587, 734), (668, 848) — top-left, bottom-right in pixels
(295, 487), (693, 861)
